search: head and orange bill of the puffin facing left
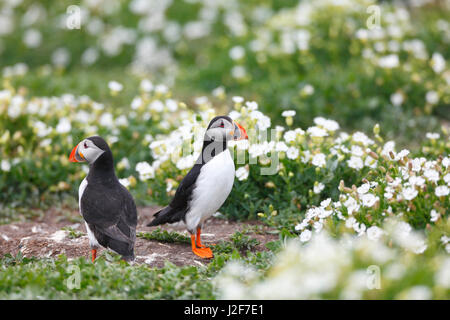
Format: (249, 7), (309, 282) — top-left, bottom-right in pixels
(69, 136), (112, 164)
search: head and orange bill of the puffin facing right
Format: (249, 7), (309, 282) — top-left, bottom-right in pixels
(205, 116), (248, 141)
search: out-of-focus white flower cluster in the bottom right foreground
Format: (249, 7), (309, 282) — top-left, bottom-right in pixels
(214, 220), (450, 299)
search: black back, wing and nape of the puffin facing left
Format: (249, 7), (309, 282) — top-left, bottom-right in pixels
(80, 137), (137, 260)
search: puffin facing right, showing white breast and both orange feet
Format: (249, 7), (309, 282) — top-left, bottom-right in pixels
(147, 116), (248, 259)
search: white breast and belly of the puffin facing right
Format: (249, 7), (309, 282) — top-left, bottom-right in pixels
(186, 149), (236, 231)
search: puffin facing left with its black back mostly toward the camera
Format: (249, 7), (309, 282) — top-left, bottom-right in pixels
(69, 136), (137, 262)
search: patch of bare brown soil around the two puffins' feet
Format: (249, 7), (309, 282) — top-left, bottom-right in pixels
(0, 207), (277, 267)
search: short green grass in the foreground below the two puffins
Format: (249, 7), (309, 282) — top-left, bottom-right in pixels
(0, 229), (271, 299)
